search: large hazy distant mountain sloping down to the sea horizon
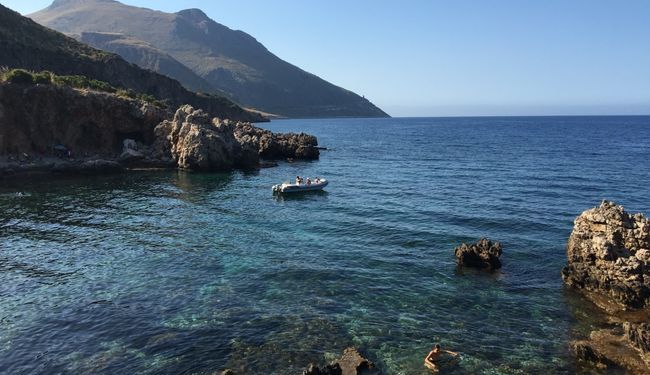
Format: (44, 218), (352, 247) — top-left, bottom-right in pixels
(30, 0), (387, 117)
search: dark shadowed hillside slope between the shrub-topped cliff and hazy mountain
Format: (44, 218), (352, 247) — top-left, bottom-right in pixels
(0, 5), (263, 121)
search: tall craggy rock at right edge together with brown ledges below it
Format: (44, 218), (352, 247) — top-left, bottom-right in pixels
(562, 201), (650, 374)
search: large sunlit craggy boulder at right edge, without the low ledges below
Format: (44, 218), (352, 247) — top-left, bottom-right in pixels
(562, 201), (650, 308)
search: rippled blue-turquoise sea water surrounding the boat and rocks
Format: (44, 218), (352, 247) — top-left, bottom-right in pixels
(0, 117), (650, 374)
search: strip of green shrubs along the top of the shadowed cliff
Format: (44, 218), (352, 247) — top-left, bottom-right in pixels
(0, 69), (168, 108)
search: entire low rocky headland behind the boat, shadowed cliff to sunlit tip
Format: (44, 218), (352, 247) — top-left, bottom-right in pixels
(0, 82), (319, 177)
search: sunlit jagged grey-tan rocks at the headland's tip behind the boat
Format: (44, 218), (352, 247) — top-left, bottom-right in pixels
(154, 106), (318, 170)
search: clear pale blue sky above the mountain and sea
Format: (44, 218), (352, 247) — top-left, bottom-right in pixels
(5, 0), (650, 116)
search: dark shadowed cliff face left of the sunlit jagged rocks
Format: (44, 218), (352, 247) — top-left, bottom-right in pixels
(0, 83), (169, 155)
